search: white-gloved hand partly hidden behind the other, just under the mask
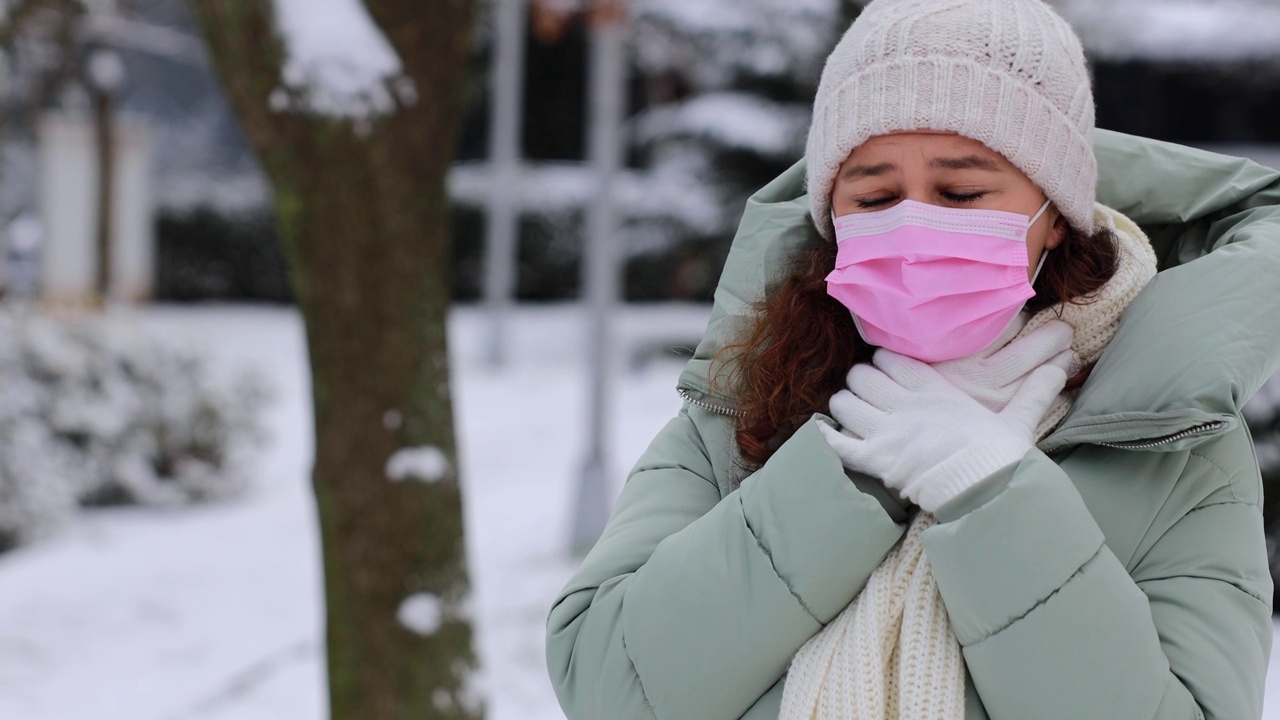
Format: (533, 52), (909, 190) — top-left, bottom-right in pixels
(931, 314), (1079, 413)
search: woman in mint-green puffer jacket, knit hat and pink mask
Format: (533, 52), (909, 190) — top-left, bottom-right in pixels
(548, 0), (1280, 720)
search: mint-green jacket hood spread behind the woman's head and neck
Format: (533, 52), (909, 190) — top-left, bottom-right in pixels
(678, 131), (1280, 451)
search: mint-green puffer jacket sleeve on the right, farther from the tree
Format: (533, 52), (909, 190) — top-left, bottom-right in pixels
(925, 429), (1272, 720)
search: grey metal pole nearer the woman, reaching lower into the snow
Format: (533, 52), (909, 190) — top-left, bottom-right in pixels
(571, 0), (626, 553)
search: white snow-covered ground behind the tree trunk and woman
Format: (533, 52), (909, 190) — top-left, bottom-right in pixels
(0, 306), (1280, 720)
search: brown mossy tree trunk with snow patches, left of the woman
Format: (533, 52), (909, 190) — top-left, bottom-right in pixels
(193, 0), (481, 720)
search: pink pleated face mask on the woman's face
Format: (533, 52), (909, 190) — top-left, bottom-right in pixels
(827, 200), (1048, 363)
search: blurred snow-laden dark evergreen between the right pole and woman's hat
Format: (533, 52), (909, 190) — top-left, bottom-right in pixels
(614, 0), (852, 258)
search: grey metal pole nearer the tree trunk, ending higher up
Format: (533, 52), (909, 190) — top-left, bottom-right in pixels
(484, 0), (527, 366)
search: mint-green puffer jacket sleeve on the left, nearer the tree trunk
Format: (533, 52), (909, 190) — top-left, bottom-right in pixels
(547, 406), (902, 720)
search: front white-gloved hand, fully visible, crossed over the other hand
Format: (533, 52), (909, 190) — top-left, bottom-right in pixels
(818, 350), (1066, 512)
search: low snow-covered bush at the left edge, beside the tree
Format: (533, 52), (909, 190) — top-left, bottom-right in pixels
(0, 307), (266, 551)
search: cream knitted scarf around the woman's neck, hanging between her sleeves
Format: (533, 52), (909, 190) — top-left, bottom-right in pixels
(778, 205), (1156, 720)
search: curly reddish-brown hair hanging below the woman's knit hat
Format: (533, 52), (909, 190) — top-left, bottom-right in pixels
(712, 221), (1119, 470)
